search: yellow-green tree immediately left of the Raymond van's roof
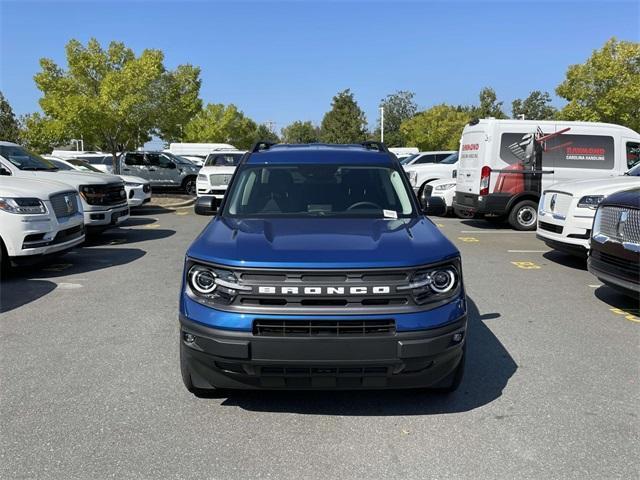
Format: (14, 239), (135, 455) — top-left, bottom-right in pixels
(400, 103), (471, 151)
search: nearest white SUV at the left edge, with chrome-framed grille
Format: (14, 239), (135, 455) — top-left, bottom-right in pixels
(0, 175), (84, 267)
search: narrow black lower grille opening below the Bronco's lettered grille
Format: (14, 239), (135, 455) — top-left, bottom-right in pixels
(253, 319), (396, 337)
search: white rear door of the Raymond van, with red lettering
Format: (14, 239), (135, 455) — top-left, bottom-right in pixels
(456, 129), (487, 195)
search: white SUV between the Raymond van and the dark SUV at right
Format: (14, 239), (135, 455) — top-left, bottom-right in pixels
(536, 164), (640, 257)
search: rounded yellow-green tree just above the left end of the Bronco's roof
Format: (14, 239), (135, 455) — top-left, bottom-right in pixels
(184, 103), (258, 149)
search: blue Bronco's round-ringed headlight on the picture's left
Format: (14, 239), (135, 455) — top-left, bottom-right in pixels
(187, 264), (251, 305)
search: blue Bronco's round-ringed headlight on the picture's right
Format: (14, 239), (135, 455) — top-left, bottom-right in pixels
(397, 264), (461, 305)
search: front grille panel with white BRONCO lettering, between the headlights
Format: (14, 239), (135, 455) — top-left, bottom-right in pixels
(186, 258), (463, 320)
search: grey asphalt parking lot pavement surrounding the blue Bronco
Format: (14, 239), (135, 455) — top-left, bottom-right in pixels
(0, 208), (640, 479)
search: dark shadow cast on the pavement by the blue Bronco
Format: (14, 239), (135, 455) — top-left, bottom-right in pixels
(222, 299), (518, 416)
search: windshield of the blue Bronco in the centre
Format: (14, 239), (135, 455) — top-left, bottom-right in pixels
(225, 164), (414, 218)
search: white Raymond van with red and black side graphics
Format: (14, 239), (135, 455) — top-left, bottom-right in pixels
(454, 119), (640, 230)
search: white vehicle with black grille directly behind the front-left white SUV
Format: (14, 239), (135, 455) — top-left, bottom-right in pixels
(0, 142), (129, 231)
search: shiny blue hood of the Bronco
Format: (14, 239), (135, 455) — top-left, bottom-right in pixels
(187, 217), (459, 268)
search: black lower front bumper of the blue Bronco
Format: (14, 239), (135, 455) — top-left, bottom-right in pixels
(180, 314), (467, 390)
